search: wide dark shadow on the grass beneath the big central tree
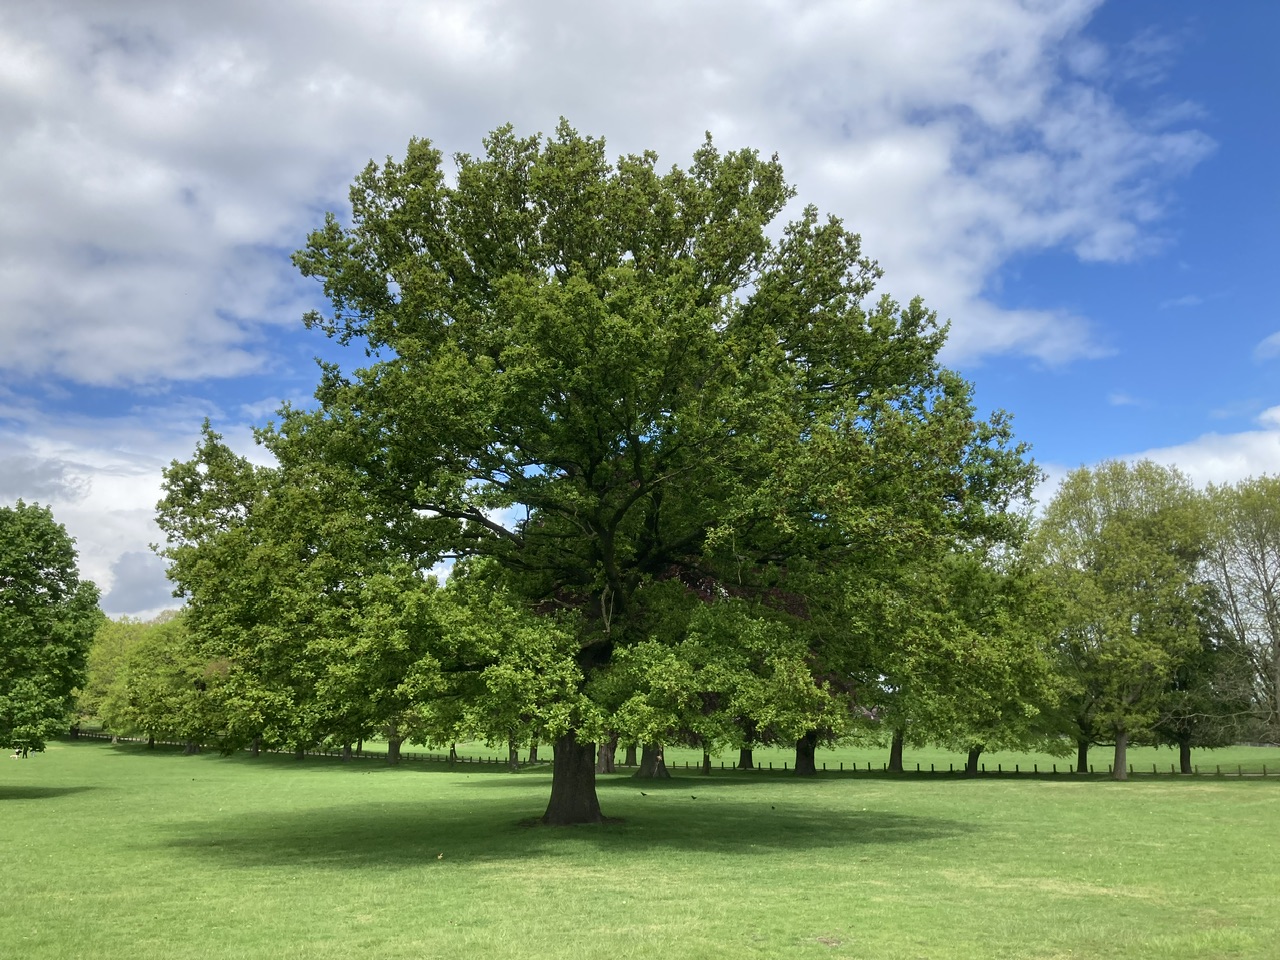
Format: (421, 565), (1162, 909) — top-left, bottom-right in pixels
(147, 794), (974, 870)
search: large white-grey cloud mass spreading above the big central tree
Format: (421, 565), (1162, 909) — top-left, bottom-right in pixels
(0, 0), (1211, 384)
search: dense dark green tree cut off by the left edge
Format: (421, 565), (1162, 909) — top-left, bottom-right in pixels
(0, 500), (102, 750)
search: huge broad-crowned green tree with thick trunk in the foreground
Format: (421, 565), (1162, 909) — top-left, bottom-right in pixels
(180, 123), (1034, 824)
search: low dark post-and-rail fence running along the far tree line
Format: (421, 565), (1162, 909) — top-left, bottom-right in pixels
(64, 730), (1276, 777)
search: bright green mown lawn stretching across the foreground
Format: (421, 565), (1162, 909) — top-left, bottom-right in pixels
(0, 741), (1280, 960)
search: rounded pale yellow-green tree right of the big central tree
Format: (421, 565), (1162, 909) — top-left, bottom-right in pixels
(1037, 461), (1206, 780)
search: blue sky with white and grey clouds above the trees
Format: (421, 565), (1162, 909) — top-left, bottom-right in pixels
(0, 0), (1280, 614)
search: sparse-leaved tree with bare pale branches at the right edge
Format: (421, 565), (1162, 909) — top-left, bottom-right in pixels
(1206, 476), (1280, 742)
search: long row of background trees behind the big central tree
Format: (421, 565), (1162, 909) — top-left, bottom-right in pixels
(79, 458), (1280, 776)
